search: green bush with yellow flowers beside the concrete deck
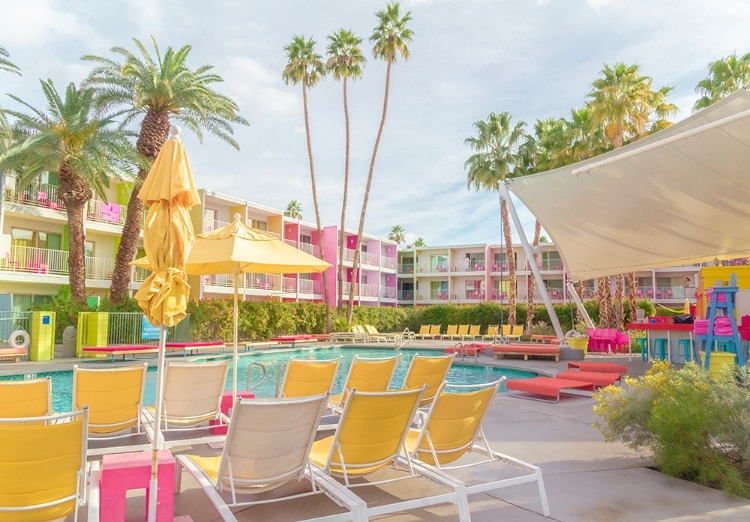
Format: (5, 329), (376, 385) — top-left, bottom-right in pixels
(594, 362), (750, 498)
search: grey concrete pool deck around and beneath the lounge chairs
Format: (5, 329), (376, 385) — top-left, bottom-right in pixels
(0, 341), (750, 522)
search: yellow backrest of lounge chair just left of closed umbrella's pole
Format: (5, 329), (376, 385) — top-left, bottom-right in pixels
(73, 363), (148, 439)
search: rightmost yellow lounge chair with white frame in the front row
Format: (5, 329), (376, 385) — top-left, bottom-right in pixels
(406, 377), (549, 517)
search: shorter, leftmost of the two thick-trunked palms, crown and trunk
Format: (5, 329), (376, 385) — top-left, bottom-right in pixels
(0, 80), (139, 306)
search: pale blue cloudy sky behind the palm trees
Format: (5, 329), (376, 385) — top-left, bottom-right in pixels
(0, 0), (750, 246)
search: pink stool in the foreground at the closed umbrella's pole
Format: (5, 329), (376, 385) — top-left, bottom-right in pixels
(99, 450), (175, 522)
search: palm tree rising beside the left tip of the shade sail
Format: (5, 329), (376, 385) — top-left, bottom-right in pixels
(464, 112), (526, 324)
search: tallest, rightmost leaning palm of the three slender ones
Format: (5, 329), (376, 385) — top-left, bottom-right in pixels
(346, 2), (414, 324)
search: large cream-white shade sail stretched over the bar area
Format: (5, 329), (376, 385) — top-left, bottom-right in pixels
(509, 90), (750, 280)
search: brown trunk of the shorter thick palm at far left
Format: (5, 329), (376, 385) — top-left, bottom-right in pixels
(58, 165), (92, 306)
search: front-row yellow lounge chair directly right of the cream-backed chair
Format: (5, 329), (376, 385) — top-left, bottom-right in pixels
(310, 387), (470, 521)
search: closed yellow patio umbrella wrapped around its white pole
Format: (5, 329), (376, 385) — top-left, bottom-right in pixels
(135, 127), (200, 521)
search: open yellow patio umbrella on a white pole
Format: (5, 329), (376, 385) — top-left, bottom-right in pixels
(132, 214), (331, 402)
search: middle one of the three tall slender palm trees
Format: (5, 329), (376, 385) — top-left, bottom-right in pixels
(326, 29), (365, 314)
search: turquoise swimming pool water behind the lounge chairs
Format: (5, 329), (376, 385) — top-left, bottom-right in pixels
(2, 347), (536, 411)
